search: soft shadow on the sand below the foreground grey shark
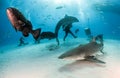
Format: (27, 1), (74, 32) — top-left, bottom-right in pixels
(59, 60), (105, 72)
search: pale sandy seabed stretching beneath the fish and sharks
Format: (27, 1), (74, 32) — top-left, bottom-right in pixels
(0, 39), (120, 78)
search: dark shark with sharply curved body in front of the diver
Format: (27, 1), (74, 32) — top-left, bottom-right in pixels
(55, 15), (79, 45)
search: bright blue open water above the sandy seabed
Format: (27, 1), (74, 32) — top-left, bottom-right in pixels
(0, 0), (120, 46)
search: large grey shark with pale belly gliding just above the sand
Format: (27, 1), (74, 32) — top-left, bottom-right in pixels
(58, 38), (104, 63)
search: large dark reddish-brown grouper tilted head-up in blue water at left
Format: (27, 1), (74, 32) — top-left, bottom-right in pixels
(7, 7), (41, 40)
